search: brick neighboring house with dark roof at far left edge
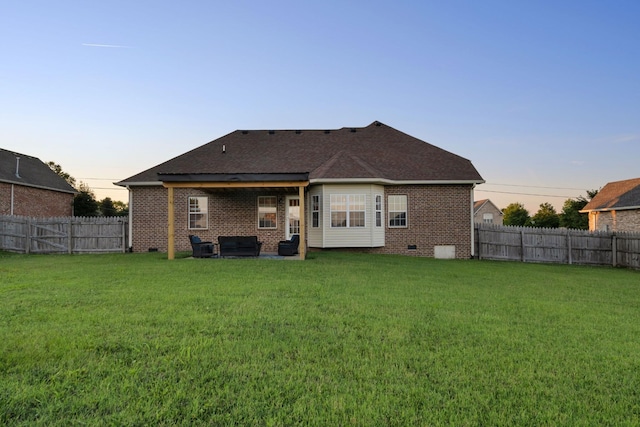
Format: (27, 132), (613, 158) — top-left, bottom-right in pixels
(0, 148), (77, 217)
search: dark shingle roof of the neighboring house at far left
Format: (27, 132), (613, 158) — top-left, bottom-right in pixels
(0, 148), (77, 194)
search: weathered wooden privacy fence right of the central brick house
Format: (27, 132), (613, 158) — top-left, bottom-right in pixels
(475, 224), (640, 269)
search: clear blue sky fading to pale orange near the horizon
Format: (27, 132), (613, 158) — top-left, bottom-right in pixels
(0, 0), (640, 215)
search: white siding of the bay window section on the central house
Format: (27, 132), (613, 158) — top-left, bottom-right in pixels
(307, 184), (385, 248)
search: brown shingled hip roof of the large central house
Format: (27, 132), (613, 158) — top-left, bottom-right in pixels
(117, 122), (484, 186)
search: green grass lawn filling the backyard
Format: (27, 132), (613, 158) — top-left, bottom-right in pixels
(0, 252), (640, 426)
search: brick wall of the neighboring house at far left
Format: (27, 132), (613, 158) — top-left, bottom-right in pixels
(0, 183), (73, 218)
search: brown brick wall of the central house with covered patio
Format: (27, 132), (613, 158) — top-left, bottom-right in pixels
(130, 185), (471, 258)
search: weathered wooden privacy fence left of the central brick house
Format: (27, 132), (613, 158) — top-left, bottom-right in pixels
(0, 215), (128, 254)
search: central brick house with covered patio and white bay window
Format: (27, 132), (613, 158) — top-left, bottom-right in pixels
(117, 122), (484, 259)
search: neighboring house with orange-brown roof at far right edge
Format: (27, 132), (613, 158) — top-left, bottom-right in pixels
(580, 178), (640, 232)
